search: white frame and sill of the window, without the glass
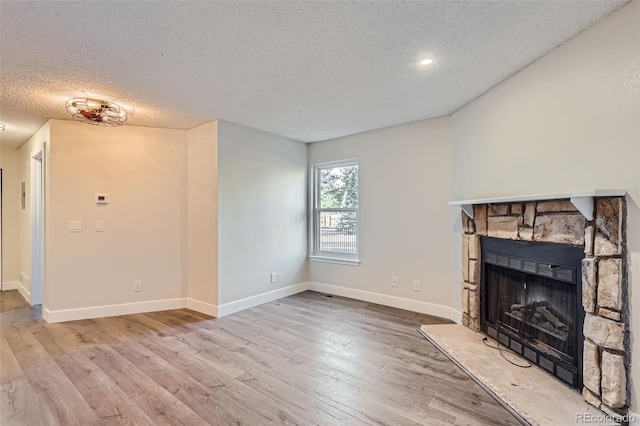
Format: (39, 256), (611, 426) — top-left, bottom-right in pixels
(309, 158), (360, 266)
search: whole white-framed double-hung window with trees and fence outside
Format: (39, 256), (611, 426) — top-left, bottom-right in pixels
(311, 160), (359, 264)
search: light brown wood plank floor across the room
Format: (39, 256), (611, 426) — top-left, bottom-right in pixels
(0, 290), (518, 426)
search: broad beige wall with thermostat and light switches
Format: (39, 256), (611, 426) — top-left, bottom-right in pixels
(45, 120), (187, 311)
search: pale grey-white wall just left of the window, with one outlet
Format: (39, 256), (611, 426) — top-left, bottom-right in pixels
(218, 121), (308, 305)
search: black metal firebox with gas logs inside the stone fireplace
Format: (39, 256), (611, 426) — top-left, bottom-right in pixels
(480, 237), (584, 390)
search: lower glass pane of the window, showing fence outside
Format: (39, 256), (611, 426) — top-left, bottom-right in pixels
(318, 212), (357, 254)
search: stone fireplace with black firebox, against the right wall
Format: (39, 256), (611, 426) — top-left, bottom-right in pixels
(460, 193), (630, 415)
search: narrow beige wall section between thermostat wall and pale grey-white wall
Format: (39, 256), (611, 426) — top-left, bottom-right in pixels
(187, 121), (218, 305)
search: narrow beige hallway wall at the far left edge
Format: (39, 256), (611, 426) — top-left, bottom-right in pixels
(0, 149), (21, 282)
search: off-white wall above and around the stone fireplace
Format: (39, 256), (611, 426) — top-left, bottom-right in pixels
(452, 1), (640, 412)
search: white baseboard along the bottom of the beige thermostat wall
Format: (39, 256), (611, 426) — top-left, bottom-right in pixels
(42, 298), (187, 323)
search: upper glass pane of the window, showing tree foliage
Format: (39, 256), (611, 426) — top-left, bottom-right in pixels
(320, 166), (358, 209)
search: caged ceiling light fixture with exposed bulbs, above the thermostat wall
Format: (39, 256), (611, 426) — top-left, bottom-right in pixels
(65, 98), (127, 127)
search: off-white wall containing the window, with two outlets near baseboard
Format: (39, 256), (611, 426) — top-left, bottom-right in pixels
(309, 118), (452, 313)
